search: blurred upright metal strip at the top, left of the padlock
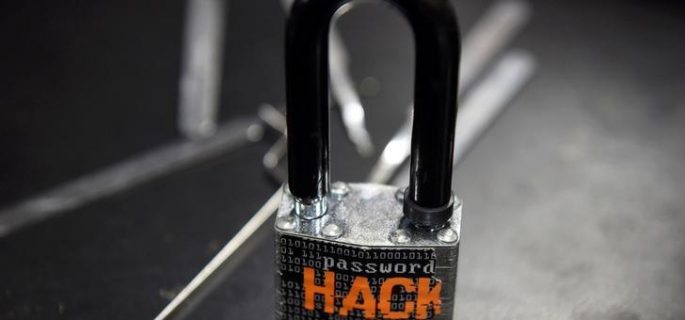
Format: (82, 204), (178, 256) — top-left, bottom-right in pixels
(178, 0), (226, 139)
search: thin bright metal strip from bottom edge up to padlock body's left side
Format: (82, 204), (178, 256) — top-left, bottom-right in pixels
(155, 189), (281, 320)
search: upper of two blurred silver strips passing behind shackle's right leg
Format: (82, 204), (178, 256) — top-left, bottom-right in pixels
(368, 0), (530, 183)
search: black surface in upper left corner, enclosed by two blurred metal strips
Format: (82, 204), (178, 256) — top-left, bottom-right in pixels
(0, 1), (183, 205)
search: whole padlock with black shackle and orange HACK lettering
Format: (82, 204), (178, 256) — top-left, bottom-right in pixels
(275, 0), (461, 320)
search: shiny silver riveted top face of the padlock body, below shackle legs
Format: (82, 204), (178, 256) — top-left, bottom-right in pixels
(276, 182), (462, 247)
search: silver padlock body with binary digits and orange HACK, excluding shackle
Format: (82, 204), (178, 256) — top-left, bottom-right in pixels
(275, 183), (462, 320)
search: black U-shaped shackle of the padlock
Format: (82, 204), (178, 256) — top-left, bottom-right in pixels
(286, 0), (460, 226)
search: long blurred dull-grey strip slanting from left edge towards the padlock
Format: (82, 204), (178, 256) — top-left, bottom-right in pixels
(0, 119), (262, 237)
